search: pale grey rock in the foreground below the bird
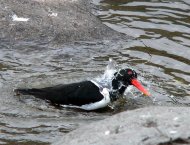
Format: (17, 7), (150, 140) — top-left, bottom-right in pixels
(55, 107), (190, 145)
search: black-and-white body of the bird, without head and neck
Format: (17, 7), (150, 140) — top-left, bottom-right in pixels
(15, 81), (110, 110)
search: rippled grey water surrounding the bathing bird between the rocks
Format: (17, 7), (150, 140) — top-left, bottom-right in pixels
(0, 0), (190, 145)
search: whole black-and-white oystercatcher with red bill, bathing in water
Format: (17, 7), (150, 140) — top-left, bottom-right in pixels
(14, 68), (150, 110)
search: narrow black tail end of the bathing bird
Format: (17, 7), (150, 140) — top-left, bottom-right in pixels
(14, 89), (45, 97)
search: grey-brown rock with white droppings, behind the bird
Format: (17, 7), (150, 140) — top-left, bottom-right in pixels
(0, 0), (128, 43)
